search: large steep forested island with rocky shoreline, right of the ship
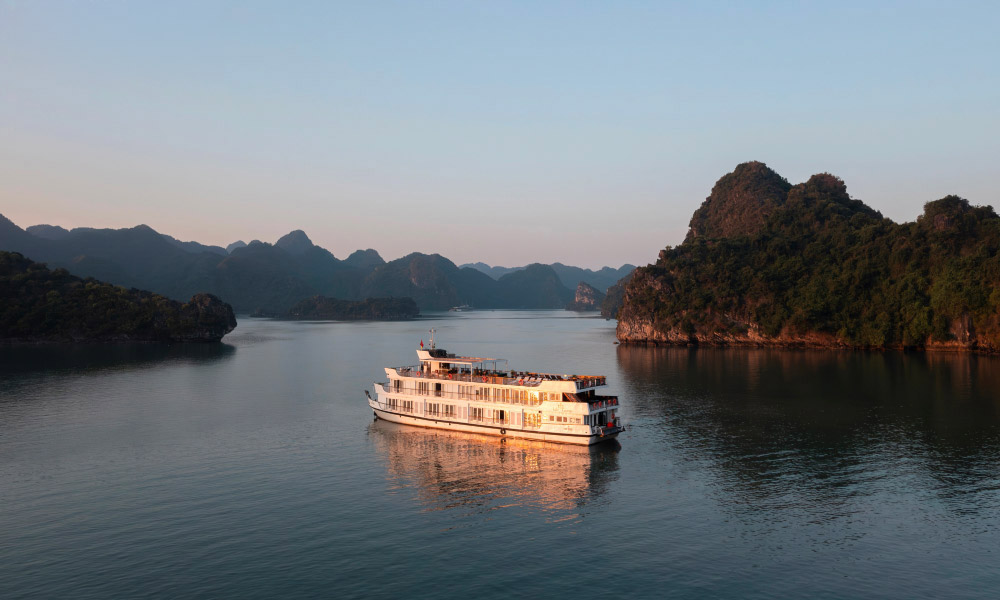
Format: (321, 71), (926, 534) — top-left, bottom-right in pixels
(609, 162), (1000, 352)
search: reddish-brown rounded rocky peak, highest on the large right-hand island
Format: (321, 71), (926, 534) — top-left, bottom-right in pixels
(685, 161), (792, 241)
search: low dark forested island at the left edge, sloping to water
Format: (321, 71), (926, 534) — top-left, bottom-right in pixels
(0, 252), (236, 342)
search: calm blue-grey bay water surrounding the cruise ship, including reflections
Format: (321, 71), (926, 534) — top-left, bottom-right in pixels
(0, 311), (1000, 598)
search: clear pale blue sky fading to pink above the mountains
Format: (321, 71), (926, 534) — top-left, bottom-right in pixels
(0, 0), (1000, 268)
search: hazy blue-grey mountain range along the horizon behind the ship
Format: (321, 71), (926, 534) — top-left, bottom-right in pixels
(0, 215), (631, 314)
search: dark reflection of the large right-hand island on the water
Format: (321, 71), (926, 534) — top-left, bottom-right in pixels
(617, 346), (1000, 520)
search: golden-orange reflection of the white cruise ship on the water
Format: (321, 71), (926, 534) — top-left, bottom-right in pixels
(369, 421), (620, 518)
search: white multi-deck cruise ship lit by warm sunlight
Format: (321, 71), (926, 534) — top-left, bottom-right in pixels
(365, 337), (623, 445)
